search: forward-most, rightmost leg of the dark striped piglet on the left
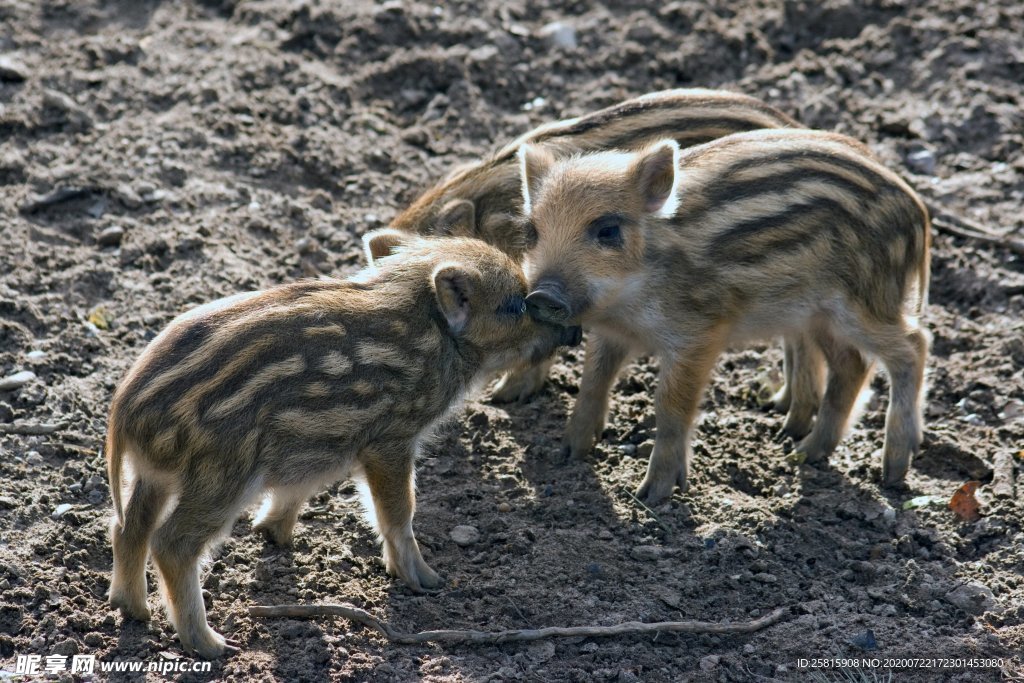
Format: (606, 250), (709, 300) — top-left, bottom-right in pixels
(359, 444), (441, 593)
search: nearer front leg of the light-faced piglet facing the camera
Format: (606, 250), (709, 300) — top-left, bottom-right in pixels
(637, 329), (725, 505)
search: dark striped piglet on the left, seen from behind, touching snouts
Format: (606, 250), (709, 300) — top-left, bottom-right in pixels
(106, 230), (581, 657)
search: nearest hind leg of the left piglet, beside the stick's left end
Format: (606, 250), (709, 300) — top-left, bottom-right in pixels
(153, 476), (246, 659)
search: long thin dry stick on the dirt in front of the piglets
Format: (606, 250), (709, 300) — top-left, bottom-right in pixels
(249, 604), (788, 645)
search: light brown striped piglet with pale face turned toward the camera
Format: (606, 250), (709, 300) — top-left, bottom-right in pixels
(520, 130), (930, 503)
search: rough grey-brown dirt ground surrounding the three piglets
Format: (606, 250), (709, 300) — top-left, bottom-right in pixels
(0, 0), (1024, 682)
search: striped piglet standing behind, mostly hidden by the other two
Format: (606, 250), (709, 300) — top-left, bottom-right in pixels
(391, 88), (820, 411)
